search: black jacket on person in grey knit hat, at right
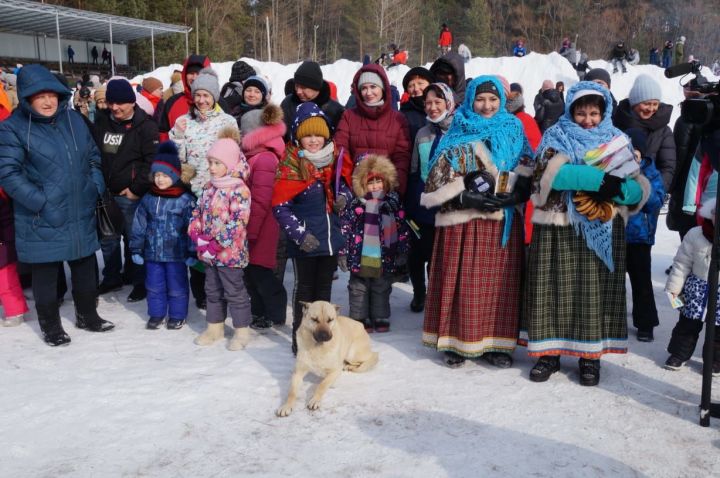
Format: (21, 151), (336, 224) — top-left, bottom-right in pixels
(613, 99), (676, 191)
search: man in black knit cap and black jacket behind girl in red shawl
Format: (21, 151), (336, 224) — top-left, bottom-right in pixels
(280, 61), (345, 142)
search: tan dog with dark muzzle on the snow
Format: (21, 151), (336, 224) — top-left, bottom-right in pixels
(276, 300), (378, 417)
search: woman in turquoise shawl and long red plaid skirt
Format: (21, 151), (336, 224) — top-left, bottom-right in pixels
(420, 76), (533, 368)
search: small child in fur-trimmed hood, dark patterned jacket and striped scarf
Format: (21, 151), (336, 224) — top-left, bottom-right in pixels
(338, 155), (408, 332)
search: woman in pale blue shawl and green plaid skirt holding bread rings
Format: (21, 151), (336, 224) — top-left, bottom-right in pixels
(520, 81), (650, 386)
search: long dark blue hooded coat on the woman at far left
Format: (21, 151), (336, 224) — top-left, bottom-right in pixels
(0, 65), (105, 263)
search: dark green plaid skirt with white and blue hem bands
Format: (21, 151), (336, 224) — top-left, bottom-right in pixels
(518, 217), (627, 359)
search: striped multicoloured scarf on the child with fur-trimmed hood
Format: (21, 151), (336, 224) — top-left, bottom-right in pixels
(358, 191), (397, 278)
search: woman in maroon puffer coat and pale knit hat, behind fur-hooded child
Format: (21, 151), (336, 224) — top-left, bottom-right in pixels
(334, 64), (411, 197)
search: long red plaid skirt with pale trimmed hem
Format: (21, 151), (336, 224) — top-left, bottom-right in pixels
(422, 215), (523, 357)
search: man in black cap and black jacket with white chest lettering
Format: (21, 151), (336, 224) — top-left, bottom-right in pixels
(94, 78), (158, 302)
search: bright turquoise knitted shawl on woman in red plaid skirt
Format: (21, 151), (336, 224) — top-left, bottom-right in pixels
(429, 75), (532, 247)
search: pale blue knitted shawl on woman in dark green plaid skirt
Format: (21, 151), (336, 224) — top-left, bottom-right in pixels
(538, 81), (624, 272)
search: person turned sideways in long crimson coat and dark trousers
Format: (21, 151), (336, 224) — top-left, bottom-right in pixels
(240, 104), (287, 329)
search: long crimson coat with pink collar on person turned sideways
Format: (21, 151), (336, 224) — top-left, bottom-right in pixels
(242, 120), (285, 269)
